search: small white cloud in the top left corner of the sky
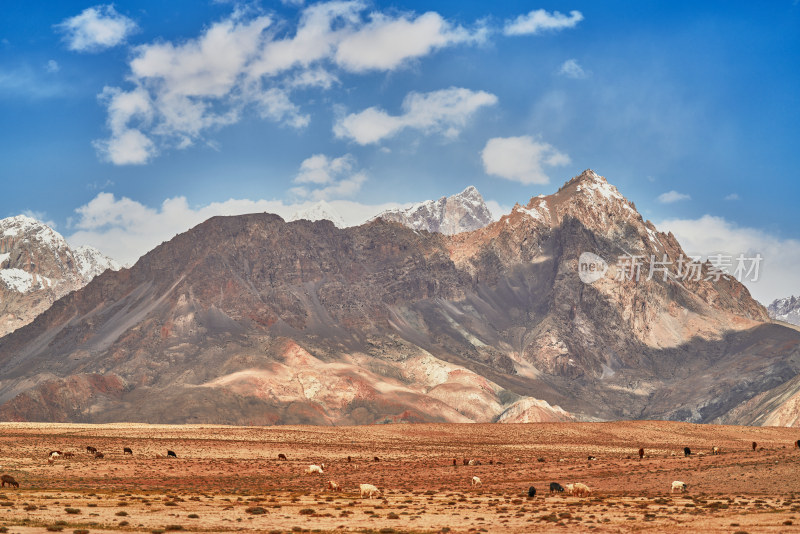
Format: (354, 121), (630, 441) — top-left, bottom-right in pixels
(56, 4), (137, 52)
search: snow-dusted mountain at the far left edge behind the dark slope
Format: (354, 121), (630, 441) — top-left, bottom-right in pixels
(0, 215), (120, 337)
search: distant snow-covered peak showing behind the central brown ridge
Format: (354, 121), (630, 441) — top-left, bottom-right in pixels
(376, 186), (492, 235)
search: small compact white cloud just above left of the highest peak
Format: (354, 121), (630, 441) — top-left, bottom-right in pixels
(481, 135), (570, 184)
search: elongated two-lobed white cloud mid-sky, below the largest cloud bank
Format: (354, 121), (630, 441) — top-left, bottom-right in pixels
(333, 87), (497, 145)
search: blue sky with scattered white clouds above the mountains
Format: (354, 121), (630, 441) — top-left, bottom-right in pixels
(0, 0), (800, 300)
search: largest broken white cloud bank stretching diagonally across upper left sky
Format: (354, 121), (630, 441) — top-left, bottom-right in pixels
(92, 1), (494, 164)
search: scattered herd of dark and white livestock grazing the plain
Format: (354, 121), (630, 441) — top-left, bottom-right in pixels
(0, 439), (800, 499)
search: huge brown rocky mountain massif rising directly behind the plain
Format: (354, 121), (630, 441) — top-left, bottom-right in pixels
(0, 171), (800, 424)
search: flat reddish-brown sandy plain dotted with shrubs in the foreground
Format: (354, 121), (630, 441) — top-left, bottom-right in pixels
(0, 421), (800, 534)
